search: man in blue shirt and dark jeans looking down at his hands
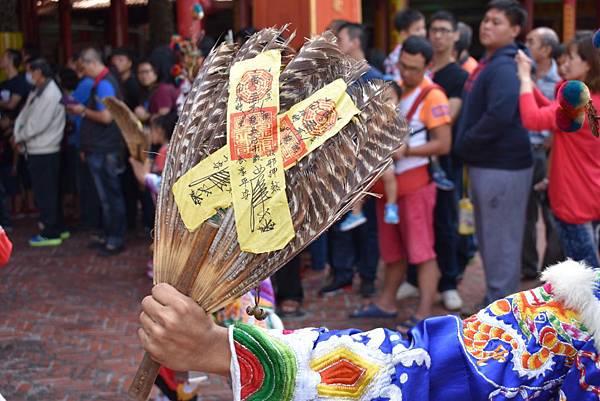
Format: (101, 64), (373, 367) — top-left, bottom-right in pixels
(67, 48), (126, 256)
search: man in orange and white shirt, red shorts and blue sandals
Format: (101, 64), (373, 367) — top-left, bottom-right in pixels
(351, 36), (451, 332)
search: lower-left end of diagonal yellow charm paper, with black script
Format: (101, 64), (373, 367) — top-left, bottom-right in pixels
(173, 146), (231, 231)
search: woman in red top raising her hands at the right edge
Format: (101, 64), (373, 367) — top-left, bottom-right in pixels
(516, 32), (600, 268)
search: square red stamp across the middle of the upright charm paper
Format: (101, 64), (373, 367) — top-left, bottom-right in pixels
(229, 107), (278, 160)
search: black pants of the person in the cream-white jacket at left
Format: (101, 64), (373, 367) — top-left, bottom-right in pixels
(27, 152), (64, 238)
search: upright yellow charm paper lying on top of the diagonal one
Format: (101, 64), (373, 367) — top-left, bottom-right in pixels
(227, 51), (294, 253)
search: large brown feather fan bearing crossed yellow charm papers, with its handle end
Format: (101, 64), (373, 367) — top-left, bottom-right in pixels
(130, 29), (407, 400)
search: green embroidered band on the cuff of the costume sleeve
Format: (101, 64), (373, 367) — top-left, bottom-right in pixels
(233, 323), (298, 401)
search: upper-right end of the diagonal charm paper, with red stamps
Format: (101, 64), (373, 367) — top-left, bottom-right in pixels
(278, 79), (360, 169)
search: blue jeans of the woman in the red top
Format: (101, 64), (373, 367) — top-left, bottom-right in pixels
(555, 218), (600, 269)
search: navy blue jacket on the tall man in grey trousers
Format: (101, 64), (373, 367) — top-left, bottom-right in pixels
(454, 43), (533, 170)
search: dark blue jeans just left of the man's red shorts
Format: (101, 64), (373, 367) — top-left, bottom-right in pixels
(327, 198), (379, 281)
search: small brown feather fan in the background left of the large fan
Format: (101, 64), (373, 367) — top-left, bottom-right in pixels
(102, 96), (150, 162)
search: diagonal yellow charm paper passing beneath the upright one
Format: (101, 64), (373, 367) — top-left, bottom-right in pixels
(173, 79), (360, 239)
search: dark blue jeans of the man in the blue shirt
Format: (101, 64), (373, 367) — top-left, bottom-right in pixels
(86, 152), (127, 247)
